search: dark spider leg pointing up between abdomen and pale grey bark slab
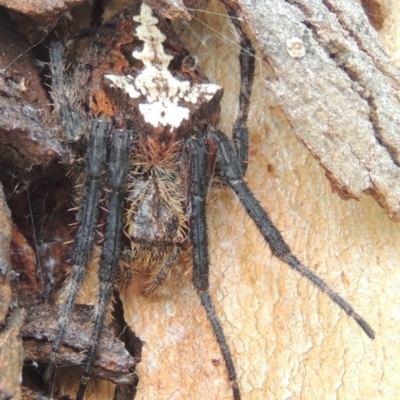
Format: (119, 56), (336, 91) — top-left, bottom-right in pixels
(223, 1), (256, 175)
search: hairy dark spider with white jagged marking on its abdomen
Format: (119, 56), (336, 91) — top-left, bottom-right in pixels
(46, 1), (374, 399)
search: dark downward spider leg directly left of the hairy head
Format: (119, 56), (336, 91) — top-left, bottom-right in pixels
(76, 130), (131, 400)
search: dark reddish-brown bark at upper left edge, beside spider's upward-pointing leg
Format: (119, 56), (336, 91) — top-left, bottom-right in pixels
(0, 10), (63, 181)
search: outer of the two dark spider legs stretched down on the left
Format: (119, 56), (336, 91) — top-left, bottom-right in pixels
(45, 121), (109, 388)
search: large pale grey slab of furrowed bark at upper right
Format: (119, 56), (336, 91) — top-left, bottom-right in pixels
(241, 0), (400, 220)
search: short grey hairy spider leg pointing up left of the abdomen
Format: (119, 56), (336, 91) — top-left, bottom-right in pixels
(49, 42), (83, 142)
